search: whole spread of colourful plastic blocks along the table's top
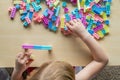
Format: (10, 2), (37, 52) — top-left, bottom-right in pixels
(9, 0), (112, 39)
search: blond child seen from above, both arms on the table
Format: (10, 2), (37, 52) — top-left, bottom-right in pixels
(11, 19), (108, 80)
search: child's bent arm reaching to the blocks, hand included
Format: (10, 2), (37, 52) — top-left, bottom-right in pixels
(66, 19), (108, 80)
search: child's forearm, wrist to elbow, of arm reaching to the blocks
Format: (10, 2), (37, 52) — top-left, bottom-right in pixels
(80, 31), (108, 63)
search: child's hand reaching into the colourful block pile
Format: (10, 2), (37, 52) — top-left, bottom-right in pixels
(66, 19), (89, 39)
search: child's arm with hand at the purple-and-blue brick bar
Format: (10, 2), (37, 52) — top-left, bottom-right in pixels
(11, 50), (33, 80)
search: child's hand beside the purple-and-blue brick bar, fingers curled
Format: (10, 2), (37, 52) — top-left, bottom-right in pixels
(15, 50), (33, 73)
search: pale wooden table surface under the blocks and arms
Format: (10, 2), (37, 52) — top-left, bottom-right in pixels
(0, 0), (120, 67)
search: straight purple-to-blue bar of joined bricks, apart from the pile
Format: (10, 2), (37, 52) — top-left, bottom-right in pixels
(22, 44), (52, 50)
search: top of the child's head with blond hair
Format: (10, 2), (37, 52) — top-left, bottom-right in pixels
(31, 61), (75, 80)
